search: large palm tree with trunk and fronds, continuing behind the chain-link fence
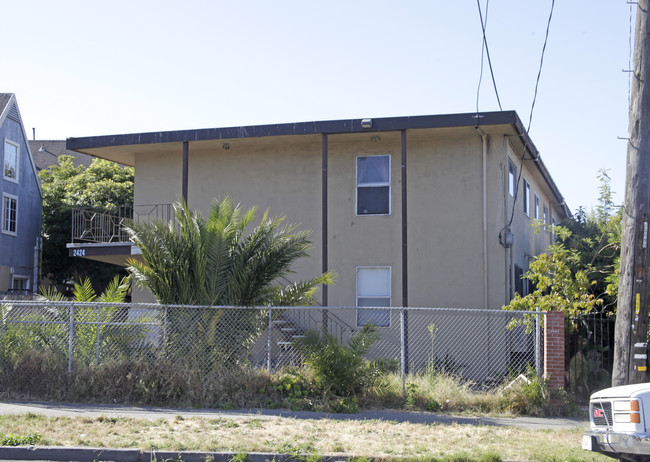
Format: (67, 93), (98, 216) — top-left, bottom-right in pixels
(127, 198), (332, 369)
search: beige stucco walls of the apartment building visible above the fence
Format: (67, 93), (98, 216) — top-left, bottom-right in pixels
(128, 127), (553, 314)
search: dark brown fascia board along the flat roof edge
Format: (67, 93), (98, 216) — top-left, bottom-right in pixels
(66, 111), (571, 216)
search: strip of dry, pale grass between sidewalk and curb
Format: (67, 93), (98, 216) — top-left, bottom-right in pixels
(0, 414), (611, 462)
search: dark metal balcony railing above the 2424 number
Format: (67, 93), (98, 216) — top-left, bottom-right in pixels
(72, 204), (175, 243)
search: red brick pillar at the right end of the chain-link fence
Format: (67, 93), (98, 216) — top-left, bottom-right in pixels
(544, 311), (564, 390)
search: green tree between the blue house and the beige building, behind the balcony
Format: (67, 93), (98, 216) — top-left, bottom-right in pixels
(39, 156), (134, 291)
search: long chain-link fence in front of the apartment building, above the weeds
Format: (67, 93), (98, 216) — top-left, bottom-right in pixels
(0, 300), (543, 397)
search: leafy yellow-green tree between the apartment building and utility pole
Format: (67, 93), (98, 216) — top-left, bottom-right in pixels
(504, 171), (621, 317)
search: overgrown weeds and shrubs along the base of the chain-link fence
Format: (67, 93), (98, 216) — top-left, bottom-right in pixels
(0, 344), (577, 415)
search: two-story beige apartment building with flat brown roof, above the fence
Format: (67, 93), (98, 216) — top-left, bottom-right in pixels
(67, 111), (570, 312)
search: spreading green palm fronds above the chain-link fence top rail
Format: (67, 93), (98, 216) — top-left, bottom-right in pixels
(127, 198), (332, 306)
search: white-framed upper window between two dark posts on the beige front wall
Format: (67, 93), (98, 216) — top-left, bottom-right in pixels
(357, 155), (390, 215)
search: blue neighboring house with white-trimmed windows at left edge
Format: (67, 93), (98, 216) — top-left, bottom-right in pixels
(0, 93), (43, 294)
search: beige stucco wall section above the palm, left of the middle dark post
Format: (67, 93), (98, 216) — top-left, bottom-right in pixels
(134, 136), (321, 301)
